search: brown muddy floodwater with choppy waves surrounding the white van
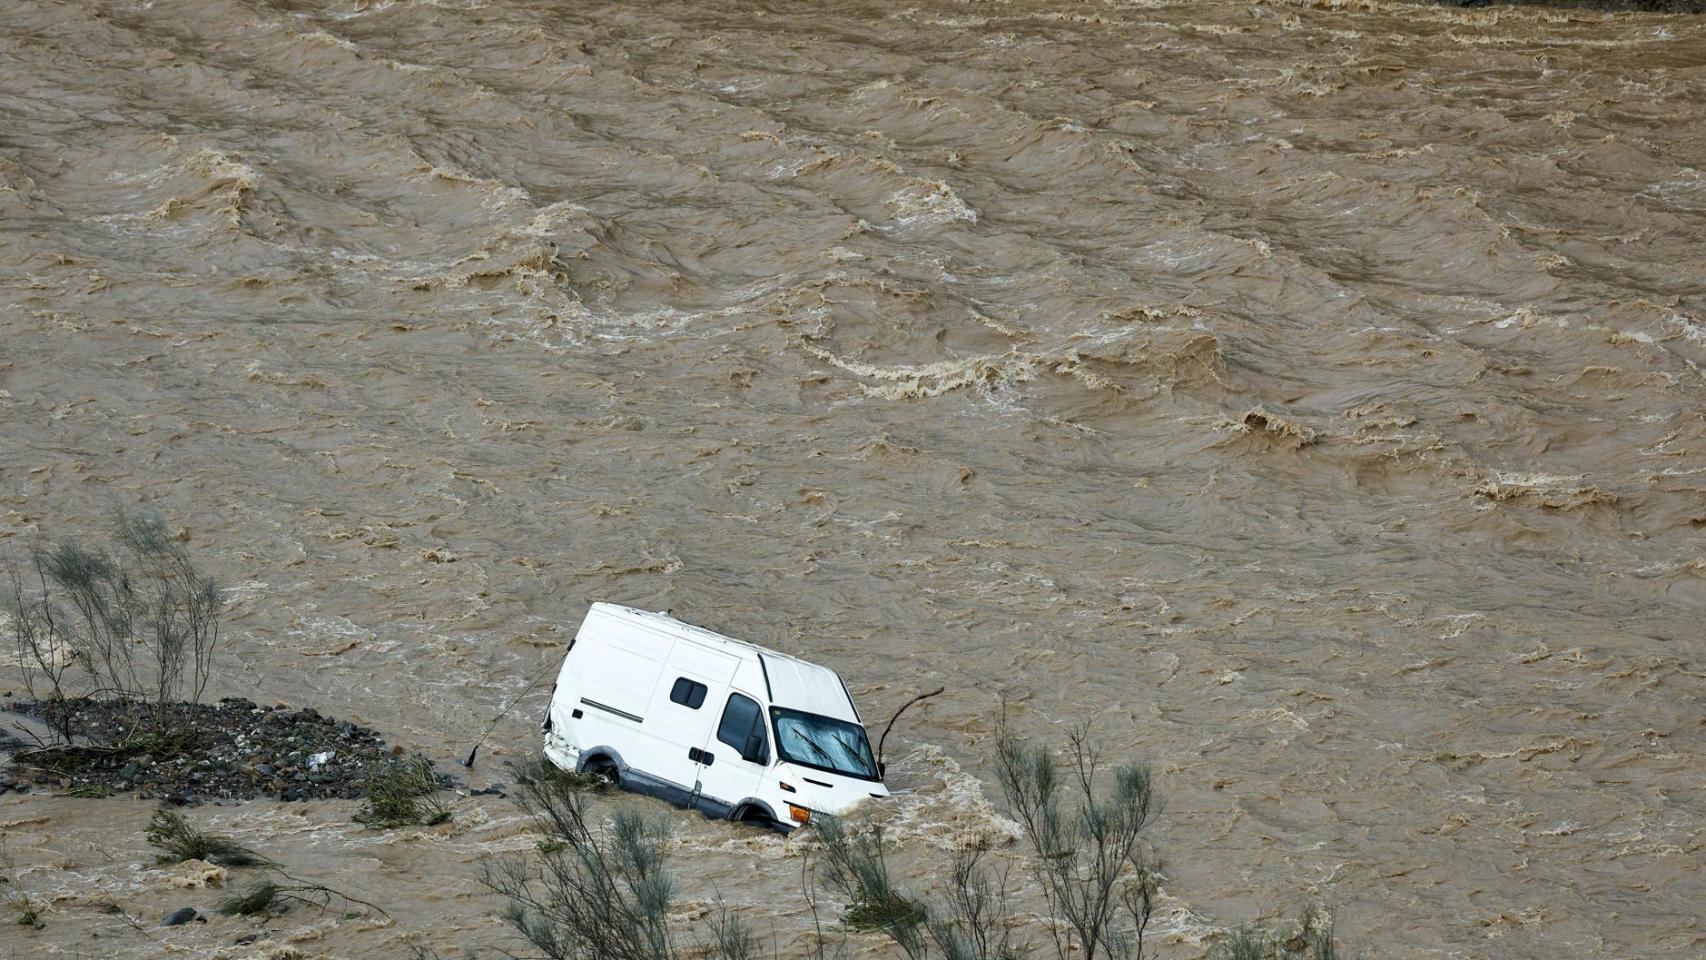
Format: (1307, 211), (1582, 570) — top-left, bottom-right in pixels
(0, 0), (1706, 960)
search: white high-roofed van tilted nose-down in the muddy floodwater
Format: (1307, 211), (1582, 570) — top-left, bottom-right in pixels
(541, 604), (889, 832)
